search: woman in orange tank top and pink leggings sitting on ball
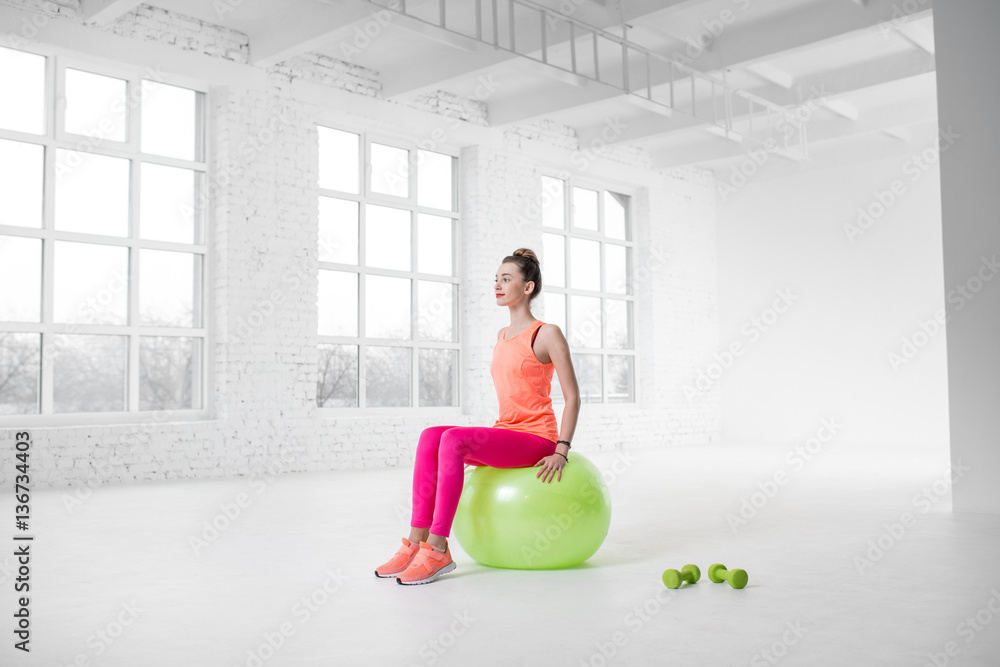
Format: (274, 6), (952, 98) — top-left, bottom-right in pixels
(375, 248), (580, 584)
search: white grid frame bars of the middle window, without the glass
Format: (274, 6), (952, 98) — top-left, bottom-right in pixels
(313, 117), (465, 412)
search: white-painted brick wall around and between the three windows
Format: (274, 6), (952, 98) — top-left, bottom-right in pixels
(0, 0), (720, 490)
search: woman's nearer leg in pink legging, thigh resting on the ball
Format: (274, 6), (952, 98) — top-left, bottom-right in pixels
(428, 426), (556, 549)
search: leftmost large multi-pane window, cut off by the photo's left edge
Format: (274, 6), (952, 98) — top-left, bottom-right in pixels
(0, 48), (206, 419)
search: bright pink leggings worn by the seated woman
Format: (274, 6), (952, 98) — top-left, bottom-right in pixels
(410, 426), (556, 537)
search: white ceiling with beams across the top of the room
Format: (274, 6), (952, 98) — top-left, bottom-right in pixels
(83, 0), (936, 175)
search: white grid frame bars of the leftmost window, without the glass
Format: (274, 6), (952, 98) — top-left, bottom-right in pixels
(0, 43), (215, 428)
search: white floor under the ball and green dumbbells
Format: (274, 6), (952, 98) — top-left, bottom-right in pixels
(0, 445), (1000, 667)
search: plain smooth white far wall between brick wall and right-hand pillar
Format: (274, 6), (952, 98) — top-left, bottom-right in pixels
(717, 122), (948, 448)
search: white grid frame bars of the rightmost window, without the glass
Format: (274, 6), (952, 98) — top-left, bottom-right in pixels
(537, 168), (643, 411)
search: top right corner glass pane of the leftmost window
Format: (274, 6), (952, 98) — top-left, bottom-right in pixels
(141, 79), (201, 160)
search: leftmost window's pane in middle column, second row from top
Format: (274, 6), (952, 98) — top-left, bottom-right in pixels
(56, 148), (129, 236)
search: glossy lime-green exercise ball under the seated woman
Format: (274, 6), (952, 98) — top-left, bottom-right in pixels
(452, 453), (611, 570)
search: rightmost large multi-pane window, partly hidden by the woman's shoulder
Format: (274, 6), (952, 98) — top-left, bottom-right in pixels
(542, 176), (635, 403)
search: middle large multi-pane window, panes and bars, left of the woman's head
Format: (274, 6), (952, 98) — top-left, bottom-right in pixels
(316, 126), (459, 408)
